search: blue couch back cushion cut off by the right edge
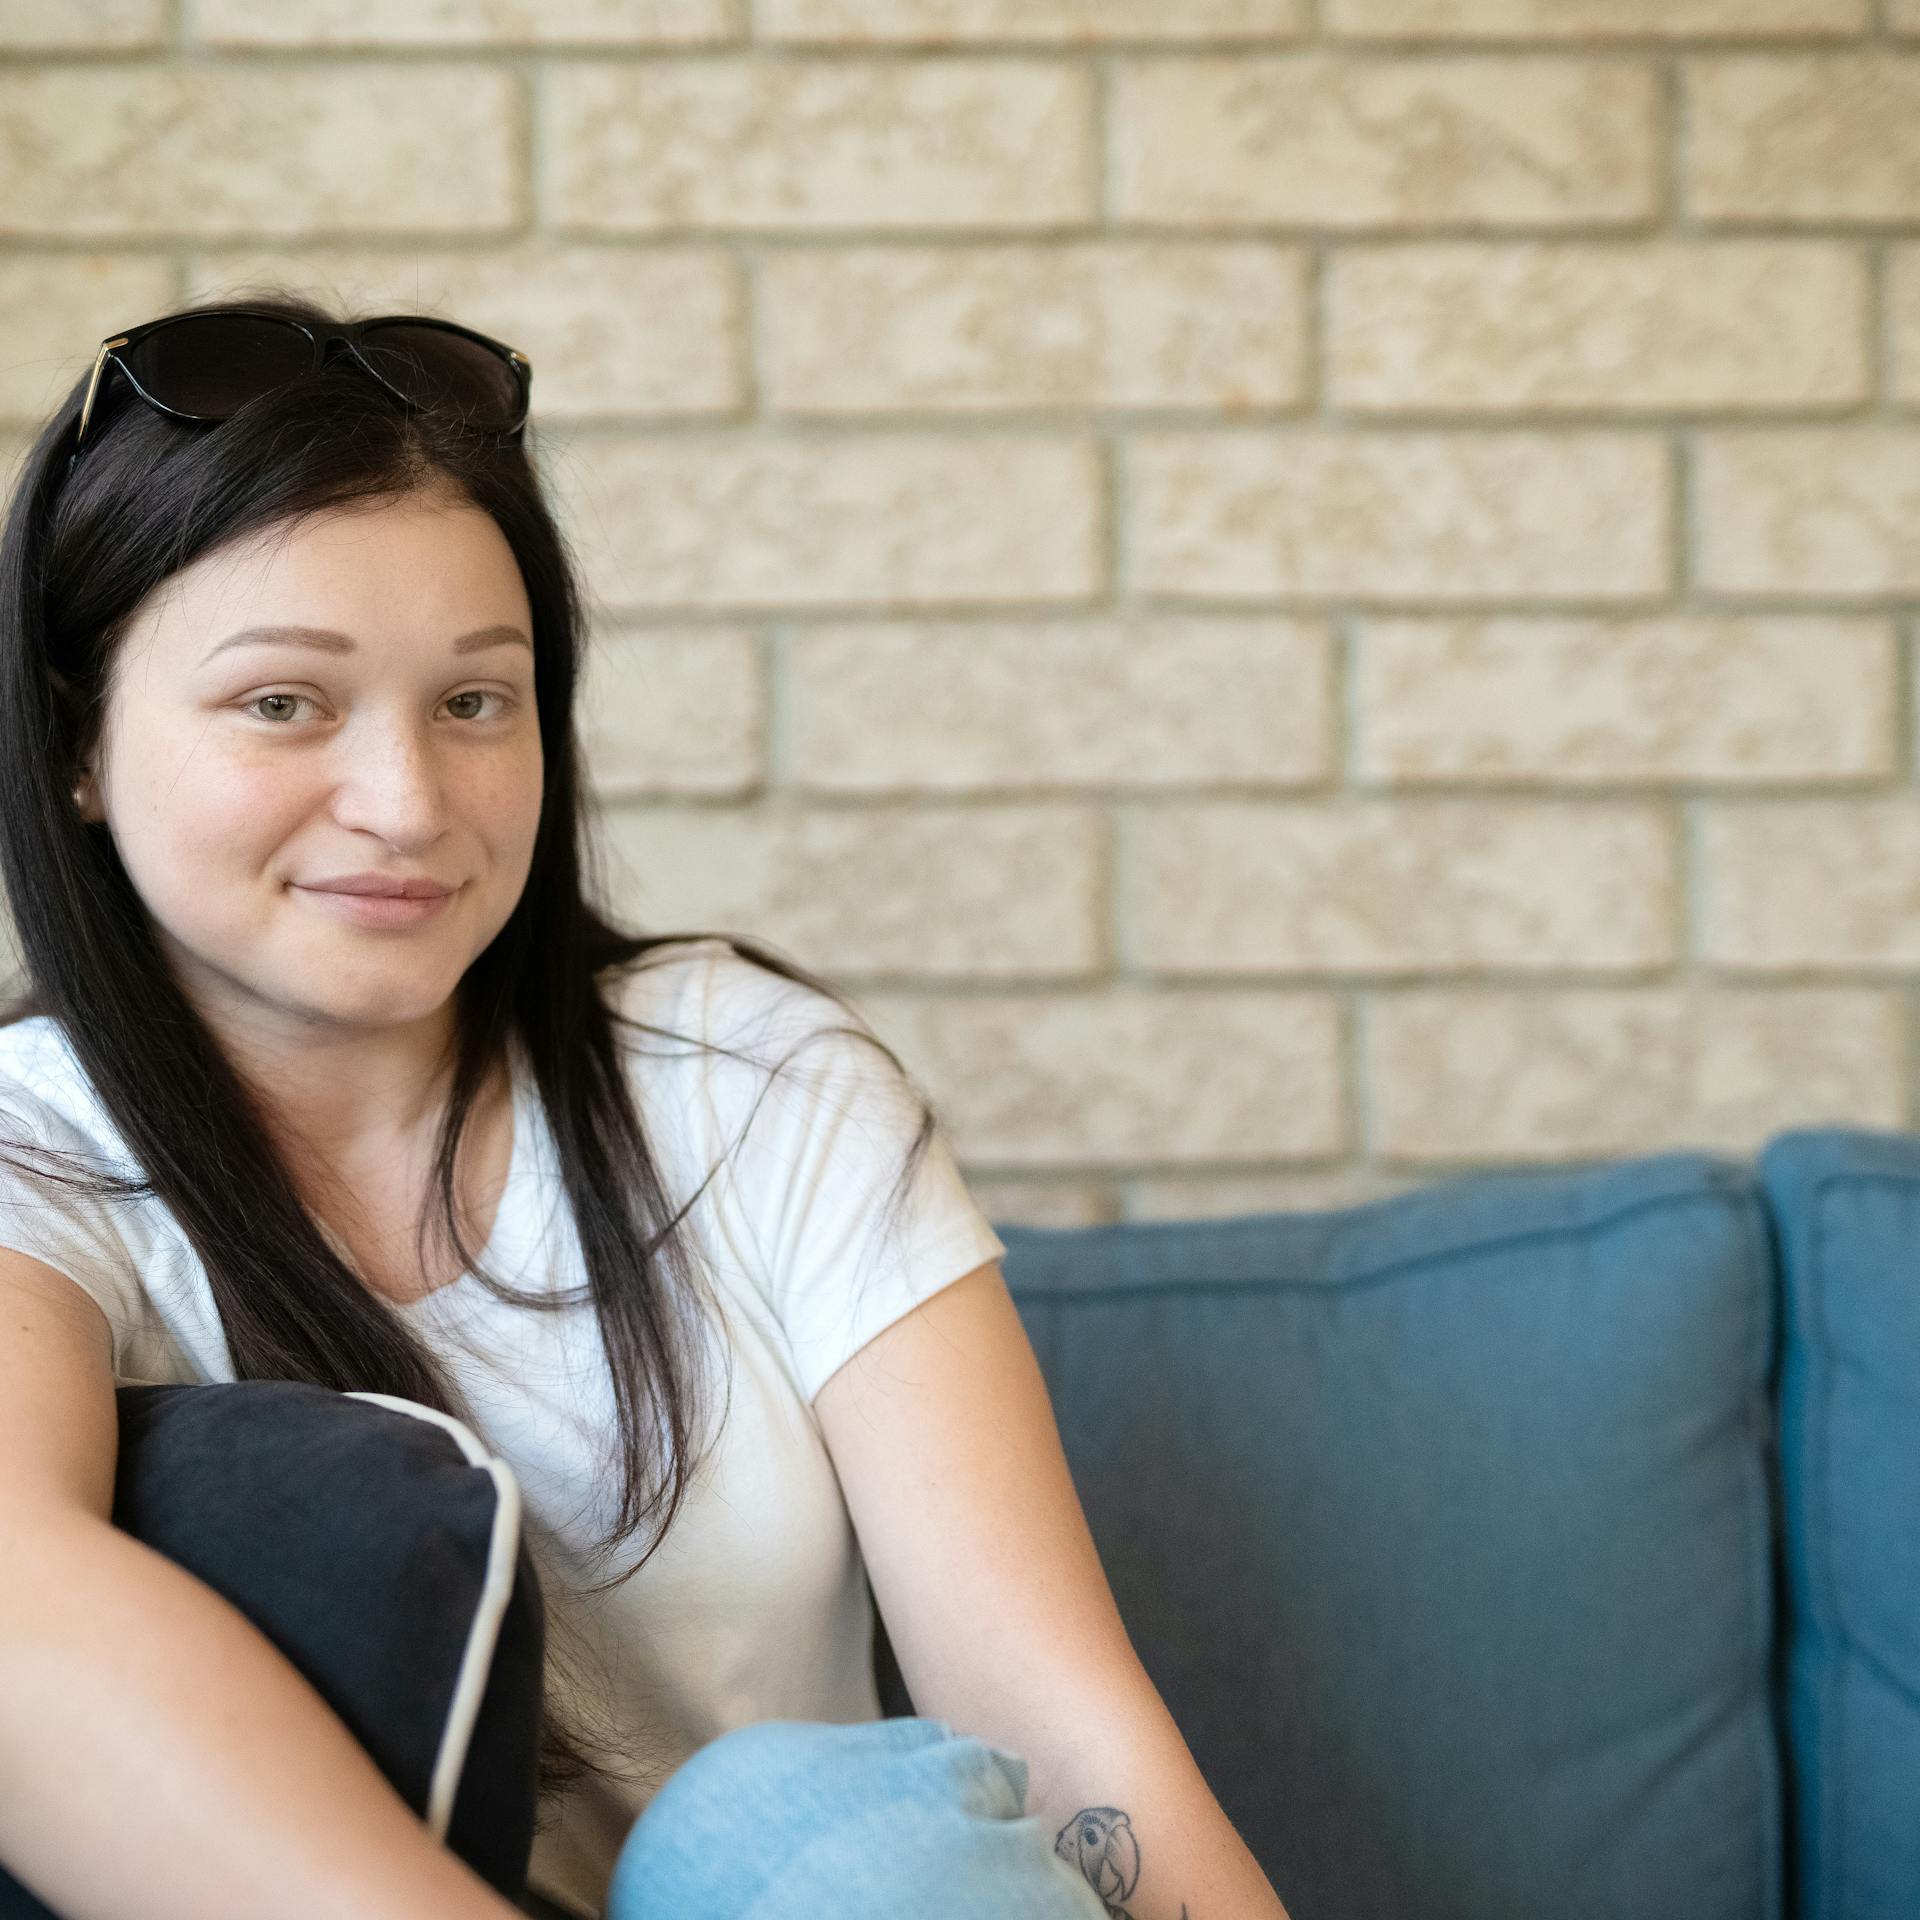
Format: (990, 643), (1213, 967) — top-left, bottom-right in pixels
(1761, 1129), (1920, 1920)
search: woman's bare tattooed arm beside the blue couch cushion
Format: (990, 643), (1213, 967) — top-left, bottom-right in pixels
(814, 1261), (1286, 1920)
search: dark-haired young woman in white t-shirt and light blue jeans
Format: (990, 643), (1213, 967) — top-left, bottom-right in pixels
(0, 296), (1284, 1920)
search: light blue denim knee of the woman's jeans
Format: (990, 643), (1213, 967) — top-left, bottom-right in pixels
(603, 1718), (1108, 1920)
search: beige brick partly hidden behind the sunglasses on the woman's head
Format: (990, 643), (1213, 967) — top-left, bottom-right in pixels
(190, 240), (749, 422)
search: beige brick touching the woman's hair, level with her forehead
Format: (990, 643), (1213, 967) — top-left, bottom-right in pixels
(549, 432), (1102, 609)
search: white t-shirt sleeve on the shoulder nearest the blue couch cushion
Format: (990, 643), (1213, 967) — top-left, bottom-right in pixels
(703, 947), (1006, 1404)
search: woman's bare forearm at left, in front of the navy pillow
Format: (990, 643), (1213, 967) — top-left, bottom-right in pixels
(0, 1500), (515, 1920)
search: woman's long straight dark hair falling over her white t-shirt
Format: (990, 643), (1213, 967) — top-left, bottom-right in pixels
(0, 290), (943, 1803)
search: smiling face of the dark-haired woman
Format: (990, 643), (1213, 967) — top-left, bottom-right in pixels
(84, 480), (543, 1039)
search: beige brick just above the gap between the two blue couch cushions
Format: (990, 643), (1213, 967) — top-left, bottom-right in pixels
(1365, 987), (1907, 1164)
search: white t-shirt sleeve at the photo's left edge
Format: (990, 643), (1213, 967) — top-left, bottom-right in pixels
(0, 1081), (144, 1379)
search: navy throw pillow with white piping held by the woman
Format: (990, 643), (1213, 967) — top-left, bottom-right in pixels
(0, 1380), (545, 1920)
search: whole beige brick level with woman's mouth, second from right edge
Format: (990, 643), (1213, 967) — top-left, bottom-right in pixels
(1125, 799), (1674, 975)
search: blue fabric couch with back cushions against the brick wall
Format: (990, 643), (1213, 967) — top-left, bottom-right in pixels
(876, 1129), (1920, 1920)
